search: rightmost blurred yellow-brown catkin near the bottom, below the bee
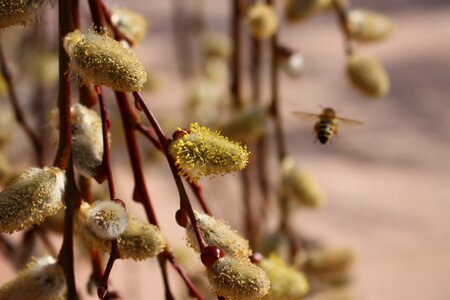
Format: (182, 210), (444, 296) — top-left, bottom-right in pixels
(303, 249), (354, 284)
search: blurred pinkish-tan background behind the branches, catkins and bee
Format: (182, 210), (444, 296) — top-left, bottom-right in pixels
(0, 0), (450, 300)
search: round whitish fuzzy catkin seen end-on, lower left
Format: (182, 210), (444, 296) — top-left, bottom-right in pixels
(80, 200), (128, 240)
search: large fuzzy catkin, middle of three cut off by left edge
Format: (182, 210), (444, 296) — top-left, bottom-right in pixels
(0, 167), (66, 233)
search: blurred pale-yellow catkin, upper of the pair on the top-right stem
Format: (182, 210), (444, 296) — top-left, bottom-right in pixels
(348, 9), (394, 42)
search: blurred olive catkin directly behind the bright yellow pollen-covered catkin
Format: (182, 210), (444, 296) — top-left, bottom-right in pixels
(219, 105), (267, 142)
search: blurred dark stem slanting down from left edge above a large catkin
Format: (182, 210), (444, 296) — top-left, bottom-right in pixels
(0, 36), (44, 167)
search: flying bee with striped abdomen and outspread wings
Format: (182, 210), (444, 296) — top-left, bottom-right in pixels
(293, 107), (363, 145)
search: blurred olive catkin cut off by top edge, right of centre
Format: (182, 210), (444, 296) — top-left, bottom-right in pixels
(284, 0), (332, 23)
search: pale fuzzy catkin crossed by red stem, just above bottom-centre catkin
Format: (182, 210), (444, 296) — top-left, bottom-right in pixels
(186, 212), (252, 258)
